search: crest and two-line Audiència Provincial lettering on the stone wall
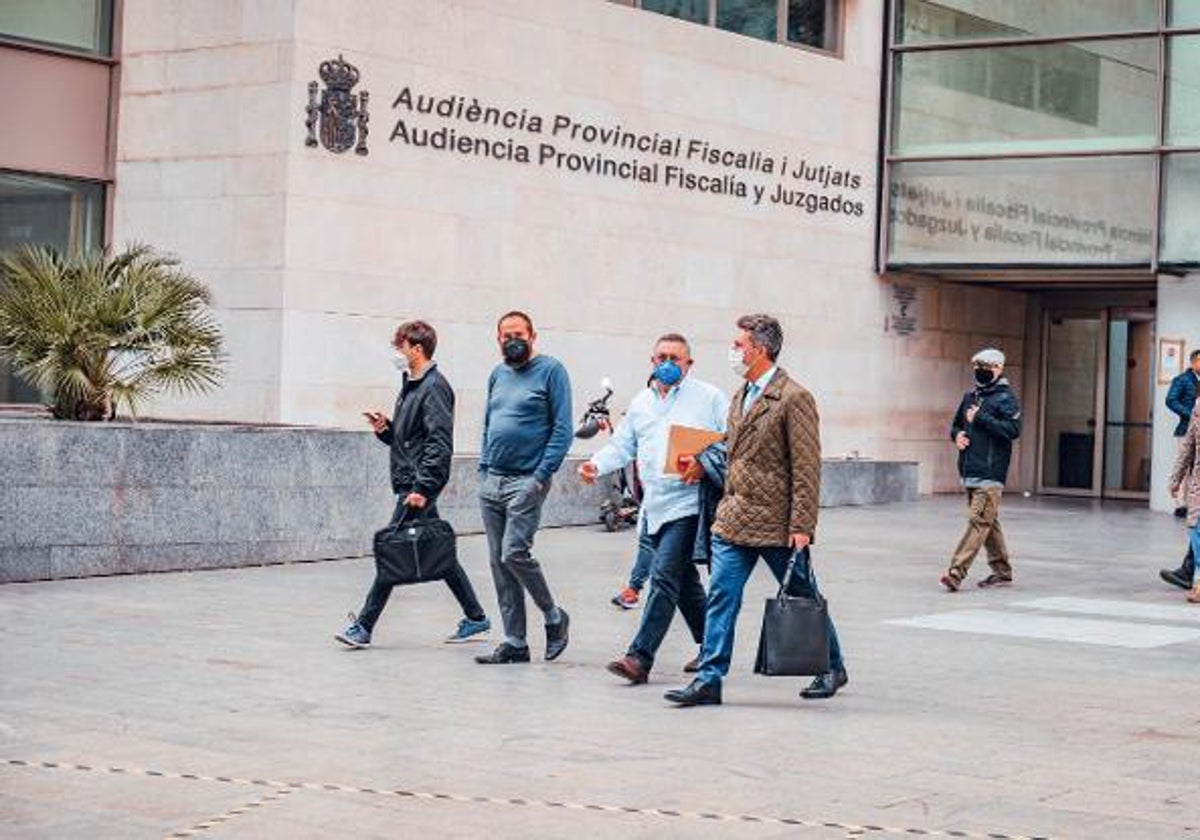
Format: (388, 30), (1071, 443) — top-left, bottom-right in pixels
(297, 56), (870, 220)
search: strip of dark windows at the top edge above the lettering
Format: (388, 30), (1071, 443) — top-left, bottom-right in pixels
(613, 0), (841, 53)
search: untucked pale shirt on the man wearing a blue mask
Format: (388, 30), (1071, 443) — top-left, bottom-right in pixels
(592, 376), (730, 534)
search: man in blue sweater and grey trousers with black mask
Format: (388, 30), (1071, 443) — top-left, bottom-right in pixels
(475, 312), (572, 665)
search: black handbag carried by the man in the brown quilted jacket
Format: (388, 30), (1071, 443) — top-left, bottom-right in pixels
(754, 550), (829, 677)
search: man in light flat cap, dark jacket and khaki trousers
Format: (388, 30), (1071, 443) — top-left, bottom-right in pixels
(942, 348), (1021, 592)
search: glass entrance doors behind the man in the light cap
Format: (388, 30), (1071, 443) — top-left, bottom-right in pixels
(1038, 310), (1154, 499)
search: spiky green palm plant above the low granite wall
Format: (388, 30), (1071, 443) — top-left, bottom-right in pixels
(0, 245), (224, 420)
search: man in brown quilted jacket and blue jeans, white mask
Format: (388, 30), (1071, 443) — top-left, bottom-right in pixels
(664, 314), (847, 706)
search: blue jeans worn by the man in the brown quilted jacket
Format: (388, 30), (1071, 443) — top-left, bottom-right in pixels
(696, 534), (845, 683)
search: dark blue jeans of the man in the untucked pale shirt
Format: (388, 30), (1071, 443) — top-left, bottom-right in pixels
(629, 516), (704, 671)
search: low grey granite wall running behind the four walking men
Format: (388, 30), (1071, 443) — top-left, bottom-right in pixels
(0, 419), (917, 583)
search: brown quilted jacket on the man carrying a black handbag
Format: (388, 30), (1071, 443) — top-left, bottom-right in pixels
(713, 368), (821, 546)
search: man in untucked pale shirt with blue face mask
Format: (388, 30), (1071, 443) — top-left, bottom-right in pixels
(580, 332), (730, 685)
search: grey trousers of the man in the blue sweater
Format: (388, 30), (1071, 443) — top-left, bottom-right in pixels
(479, 474), (554, 647)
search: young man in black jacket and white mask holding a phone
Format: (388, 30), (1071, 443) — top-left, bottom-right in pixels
(335, 320), (492, 648)
